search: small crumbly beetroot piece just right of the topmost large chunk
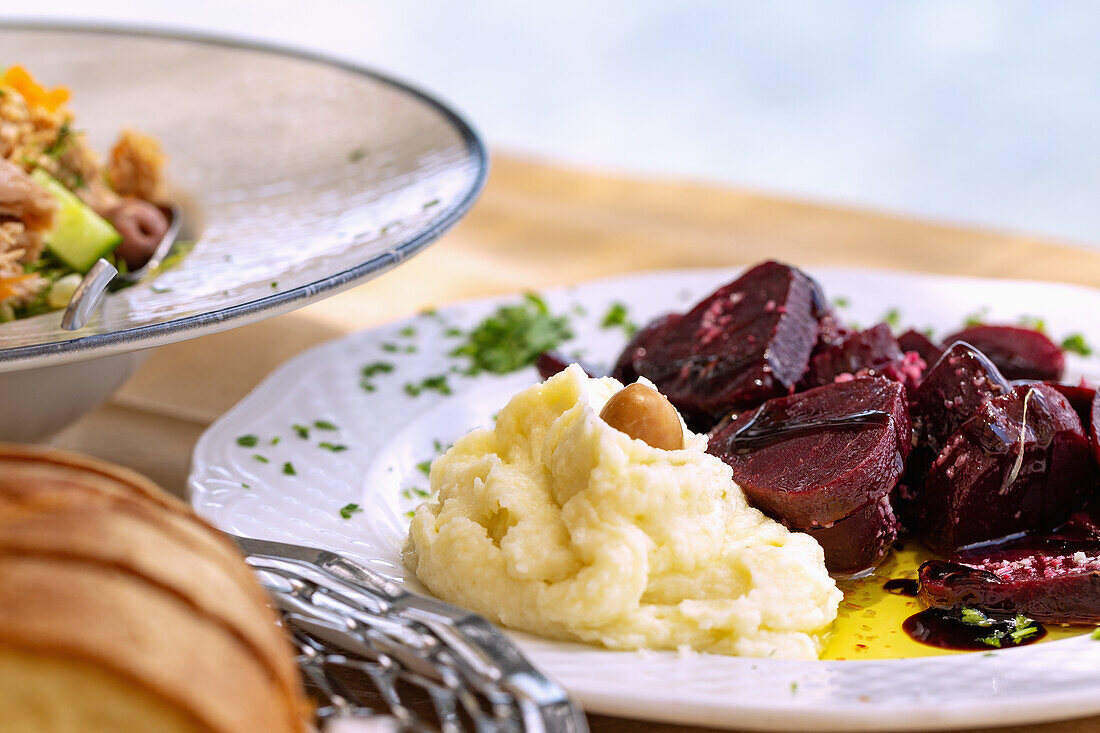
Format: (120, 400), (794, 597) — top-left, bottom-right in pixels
(802, 324), (925, 389)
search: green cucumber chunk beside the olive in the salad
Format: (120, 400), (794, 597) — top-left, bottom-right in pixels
(31, 168), (122, 273)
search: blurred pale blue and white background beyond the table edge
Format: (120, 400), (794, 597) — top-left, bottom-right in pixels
(0, 0), (1100, 249)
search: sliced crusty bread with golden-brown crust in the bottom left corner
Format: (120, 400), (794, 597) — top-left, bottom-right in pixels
(0, 444), (308, 733)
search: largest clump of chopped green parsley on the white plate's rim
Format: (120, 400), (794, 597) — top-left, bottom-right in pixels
(451, 293), (573, 374)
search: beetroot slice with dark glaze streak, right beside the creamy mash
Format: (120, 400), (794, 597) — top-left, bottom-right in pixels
(707, 378), (910, 532)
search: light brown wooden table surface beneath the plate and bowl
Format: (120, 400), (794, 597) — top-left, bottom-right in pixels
(54, 150), (1100, 733)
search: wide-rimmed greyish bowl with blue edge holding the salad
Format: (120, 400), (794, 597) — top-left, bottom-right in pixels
(0, 23), (488, 440)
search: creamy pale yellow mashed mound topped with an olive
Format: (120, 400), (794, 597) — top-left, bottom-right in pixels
(405, 365), (840, 659)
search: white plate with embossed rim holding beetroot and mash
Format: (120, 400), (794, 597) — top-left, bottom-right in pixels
(190, 269), (1100, 731)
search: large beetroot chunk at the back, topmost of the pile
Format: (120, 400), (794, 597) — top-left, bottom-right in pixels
(614, 262), (817, 427)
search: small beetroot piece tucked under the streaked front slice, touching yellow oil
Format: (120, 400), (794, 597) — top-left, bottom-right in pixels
(804, 494), (899, 577)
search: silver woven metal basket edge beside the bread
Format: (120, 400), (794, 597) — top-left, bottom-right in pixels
(229, 535), (589, 733)
